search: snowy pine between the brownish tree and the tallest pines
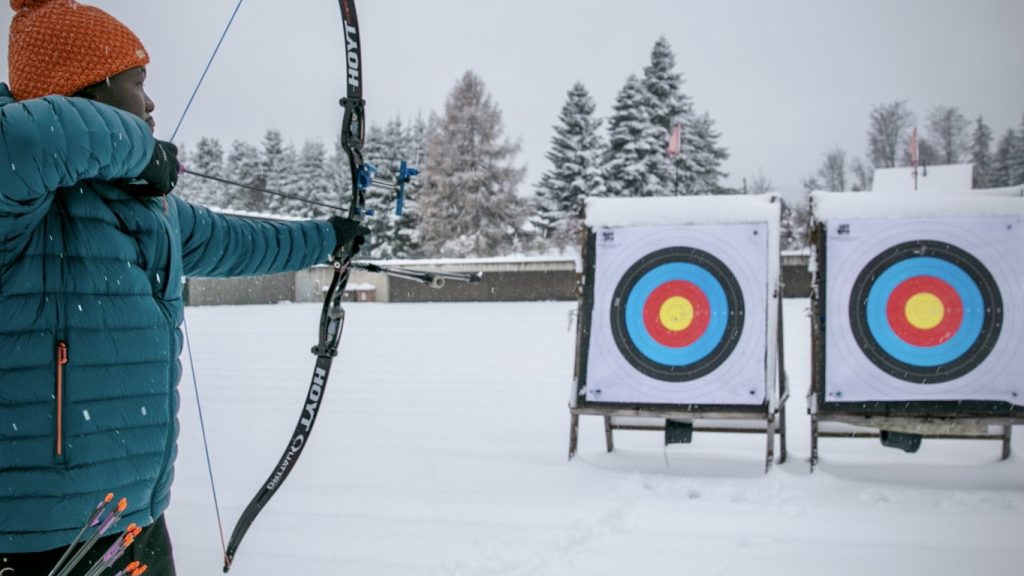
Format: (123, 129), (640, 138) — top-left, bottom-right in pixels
(532, 82), (604, 247)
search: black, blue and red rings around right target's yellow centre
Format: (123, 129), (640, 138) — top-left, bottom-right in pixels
(849, 240), (1002, 384)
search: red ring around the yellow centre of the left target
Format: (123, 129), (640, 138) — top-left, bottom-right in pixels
(643, 280), (711, 348)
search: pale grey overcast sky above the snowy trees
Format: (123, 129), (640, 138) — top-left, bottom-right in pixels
(0, 0), (1024, 192)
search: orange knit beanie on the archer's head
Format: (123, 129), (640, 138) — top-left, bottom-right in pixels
(7, 0), (150, 100)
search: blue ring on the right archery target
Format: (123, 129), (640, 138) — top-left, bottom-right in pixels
(866, 256), (985, 367)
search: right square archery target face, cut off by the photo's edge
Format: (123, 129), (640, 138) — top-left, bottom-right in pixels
(825, 217), (1024, 404)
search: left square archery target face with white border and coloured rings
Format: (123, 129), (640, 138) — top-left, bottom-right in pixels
(587, 223), (768, 404)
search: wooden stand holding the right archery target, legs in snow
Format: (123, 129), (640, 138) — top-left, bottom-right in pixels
(807, 223), (1024, 472)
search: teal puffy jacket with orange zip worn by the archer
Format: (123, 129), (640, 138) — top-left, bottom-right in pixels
(0, 84), (335, 552)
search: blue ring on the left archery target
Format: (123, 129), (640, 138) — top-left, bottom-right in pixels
(626, 262), (729, 366)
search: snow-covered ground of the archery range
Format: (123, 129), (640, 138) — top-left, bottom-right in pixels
(168, 299), (1024, 576)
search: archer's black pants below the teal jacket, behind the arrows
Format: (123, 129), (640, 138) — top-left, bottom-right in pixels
(0, 516), (175, 576)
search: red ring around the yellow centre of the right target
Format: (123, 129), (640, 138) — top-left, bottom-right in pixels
(886, 276), (964, 346)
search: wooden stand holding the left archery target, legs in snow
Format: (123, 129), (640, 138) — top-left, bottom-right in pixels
(568, 230), (790, 474)
